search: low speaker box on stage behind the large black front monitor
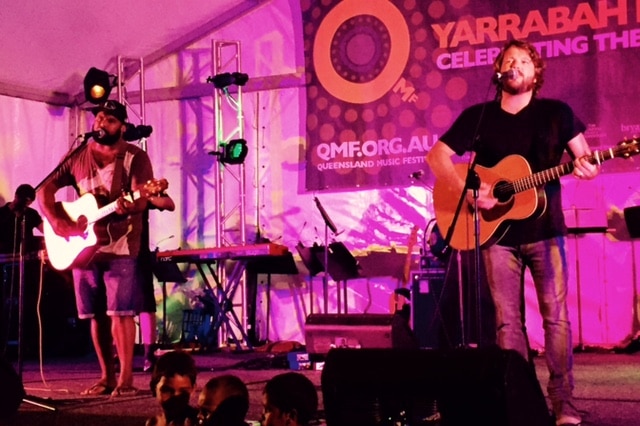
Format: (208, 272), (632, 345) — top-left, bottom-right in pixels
(304, 314), (393, 355)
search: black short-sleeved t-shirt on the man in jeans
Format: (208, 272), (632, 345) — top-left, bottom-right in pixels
(440, 98), (585, 246)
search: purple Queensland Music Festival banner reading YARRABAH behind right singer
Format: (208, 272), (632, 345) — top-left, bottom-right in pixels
(302, 0), (640, 190)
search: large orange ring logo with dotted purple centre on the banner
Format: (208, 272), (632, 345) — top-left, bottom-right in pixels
(313, 0), (411, 104)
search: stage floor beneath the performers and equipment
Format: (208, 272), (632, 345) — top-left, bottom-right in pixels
(0, 350), (640, 426)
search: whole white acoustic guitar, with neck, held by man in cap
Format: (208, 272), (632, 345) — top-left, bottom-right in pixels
(43, 179), (169, 270)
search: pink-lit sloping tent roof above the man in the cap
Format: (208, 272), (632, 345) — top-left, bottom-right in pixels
(0, 0), (264, 105)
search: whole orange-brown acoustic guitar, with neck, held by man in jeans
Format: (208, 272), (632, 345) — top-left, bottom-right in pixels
(433, 139), (640, 250)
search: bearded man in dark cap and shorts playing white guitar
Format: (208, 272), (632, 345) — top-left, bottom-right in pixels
(38, 100), (174, 396)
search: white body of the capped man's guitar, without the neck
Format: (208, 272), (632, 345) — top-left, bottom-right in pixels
(43, 193), (99, 270)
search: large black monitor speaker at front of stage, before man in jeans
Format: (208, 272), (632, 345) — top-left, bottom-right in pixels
(321, 348), (553, 426)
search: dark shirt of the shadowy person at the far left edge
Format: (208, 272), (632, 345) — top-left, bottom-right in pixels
(0, 203), (42, 253)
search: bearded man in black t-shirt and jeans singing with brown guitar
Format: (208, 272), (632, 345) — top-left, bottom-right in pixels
(427, 40), (599, 425)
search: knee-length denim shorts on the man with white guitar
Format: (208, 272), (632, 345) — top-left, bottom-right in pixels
(73, 258), (142, 319)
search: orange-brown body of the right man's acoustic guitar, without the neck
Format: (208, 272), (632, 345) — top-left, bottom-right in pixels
(433, 155), (546, 250)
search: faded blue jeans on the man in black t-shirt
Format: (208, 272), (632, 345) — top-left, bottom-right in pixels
(482, 237), (573, 411)
